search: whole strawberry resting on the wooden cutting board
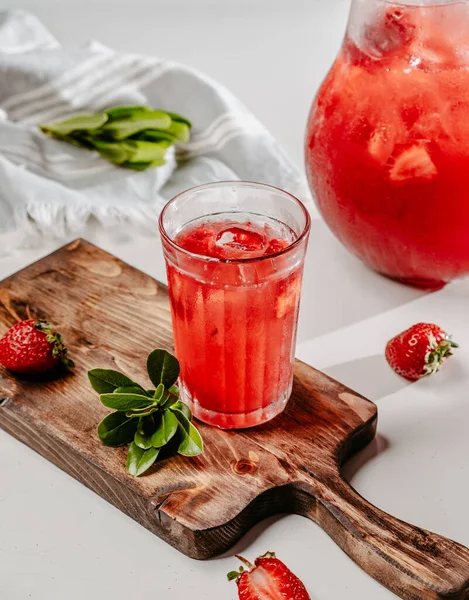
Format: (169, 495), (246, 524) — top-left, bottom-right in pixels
(0, 319), (73, 374)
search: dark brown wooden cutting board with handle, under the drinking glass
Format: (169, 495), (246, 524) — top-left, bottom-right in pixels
(0, 240), (469, 599)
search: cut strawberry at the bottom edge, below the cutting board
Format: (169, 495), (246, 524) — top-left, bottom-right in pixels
(228, 552), (311, 600)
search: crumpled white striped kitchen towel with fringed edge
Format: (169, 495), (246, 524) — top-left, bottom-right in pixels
(0, 11), (308, 255)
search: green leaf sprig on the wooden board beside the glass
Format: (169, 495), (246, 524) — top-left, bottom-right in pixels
(88, 349), (204, 477)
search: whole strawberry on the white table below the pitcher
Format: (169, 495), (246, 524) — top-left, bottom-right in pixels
(386, 323), (458, 381)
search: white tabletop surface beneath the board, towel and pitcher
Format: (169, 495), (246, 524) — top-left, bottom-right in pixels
(0, 0), (469, 600)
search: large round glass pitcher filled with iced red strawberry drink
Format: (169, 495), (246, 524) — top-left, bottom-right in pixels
(305, 0), (469, 287)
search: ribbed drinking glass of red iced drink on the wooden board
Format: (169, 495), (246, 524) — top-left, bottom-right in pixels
(160, 183), (309, 429)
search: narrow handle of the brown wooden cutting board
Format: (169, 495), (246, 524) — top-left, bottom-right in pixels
(303, 475), (469, 600)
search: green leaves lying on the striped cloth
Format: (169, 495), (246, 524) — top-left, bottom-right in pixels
(40, 106), (192, 171)
